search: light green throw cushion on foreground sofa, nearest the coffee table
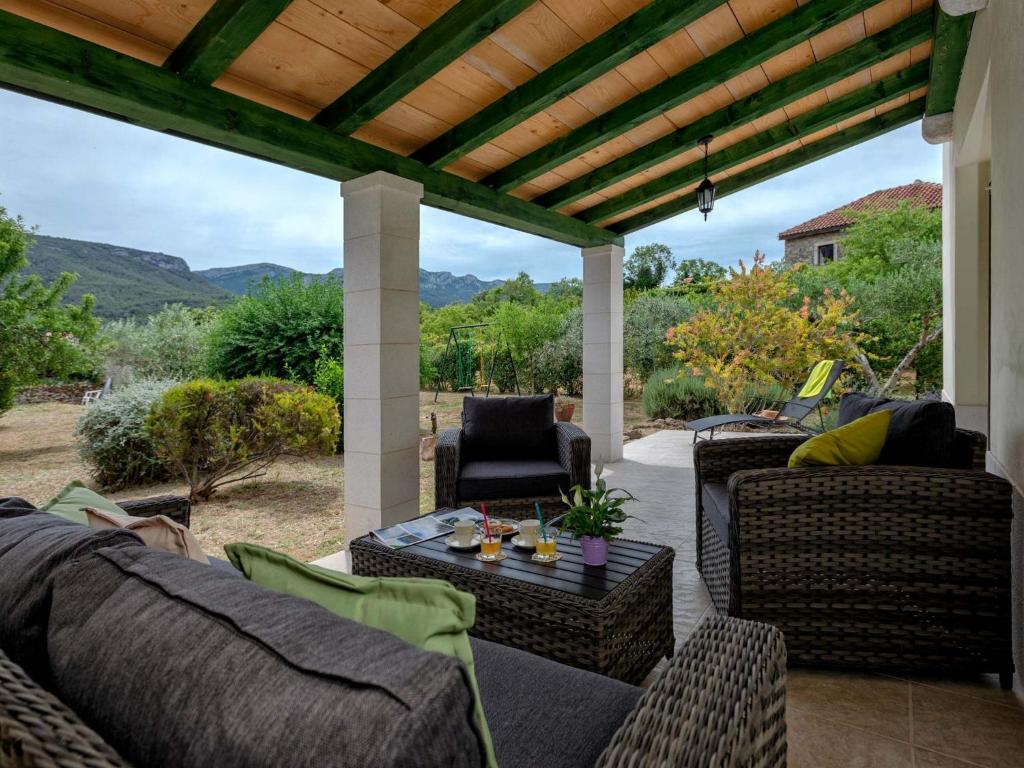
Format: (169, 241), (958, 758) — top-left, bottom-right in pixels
(224, 544), (498, 768)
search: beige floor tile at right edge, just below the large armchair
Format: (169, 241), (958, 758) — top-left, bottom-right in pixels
(910, 683), (1024, 768)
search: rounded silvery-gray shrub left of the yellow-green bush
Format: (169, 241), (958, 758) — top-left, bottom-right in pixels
(75, 381), (174, 490)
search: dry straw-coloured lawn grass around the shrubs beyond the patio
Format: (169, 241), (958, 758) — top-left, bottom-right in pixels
(0, 392), (643, 560)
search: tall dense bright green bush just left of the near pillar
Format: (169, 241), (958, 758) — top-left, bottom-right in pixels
(208, 274), (344, 384)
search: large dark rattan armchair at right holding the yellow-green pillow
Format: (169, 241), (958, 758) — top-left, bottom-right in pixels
(693, 430), (1013, 686)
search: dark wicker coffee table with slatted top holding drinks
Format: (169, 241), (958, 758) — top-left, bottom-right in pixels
(349, 510), (675, 683)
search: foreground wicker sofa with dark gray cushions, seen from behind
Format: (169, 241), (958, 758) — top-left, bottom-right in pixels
(0, 499), (785, 768)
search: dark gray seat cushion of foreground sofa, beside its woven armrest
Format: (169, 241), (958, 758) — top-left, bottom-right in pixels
(470, 638), (643, 768)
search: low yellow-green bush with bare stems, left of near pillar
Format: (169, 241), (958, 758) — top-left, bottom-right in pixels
(146, 378), (340, 502)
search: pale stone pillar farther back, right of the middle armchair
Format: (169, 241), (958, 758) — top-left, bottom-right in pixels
(583, 246), (623, 463)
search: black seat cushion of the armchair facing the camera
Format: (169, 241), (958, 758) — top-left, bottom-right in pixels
(459, 459), (569, 501)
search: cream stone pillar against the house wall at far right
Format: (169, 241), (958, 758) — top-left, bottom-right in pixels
(942, 143), (989, 434)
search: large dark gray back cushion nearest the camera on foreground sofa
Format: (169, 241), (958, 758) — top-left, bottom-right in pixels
(47, 548), (484, 768)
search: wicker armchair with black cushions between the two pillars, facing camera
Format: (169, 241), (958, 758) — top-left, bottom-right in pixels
(434, 395), (591, 519)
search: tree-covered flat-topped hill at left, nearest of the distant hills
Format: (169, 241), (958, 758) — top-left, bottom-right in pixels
(28, 234), (231, 318)
